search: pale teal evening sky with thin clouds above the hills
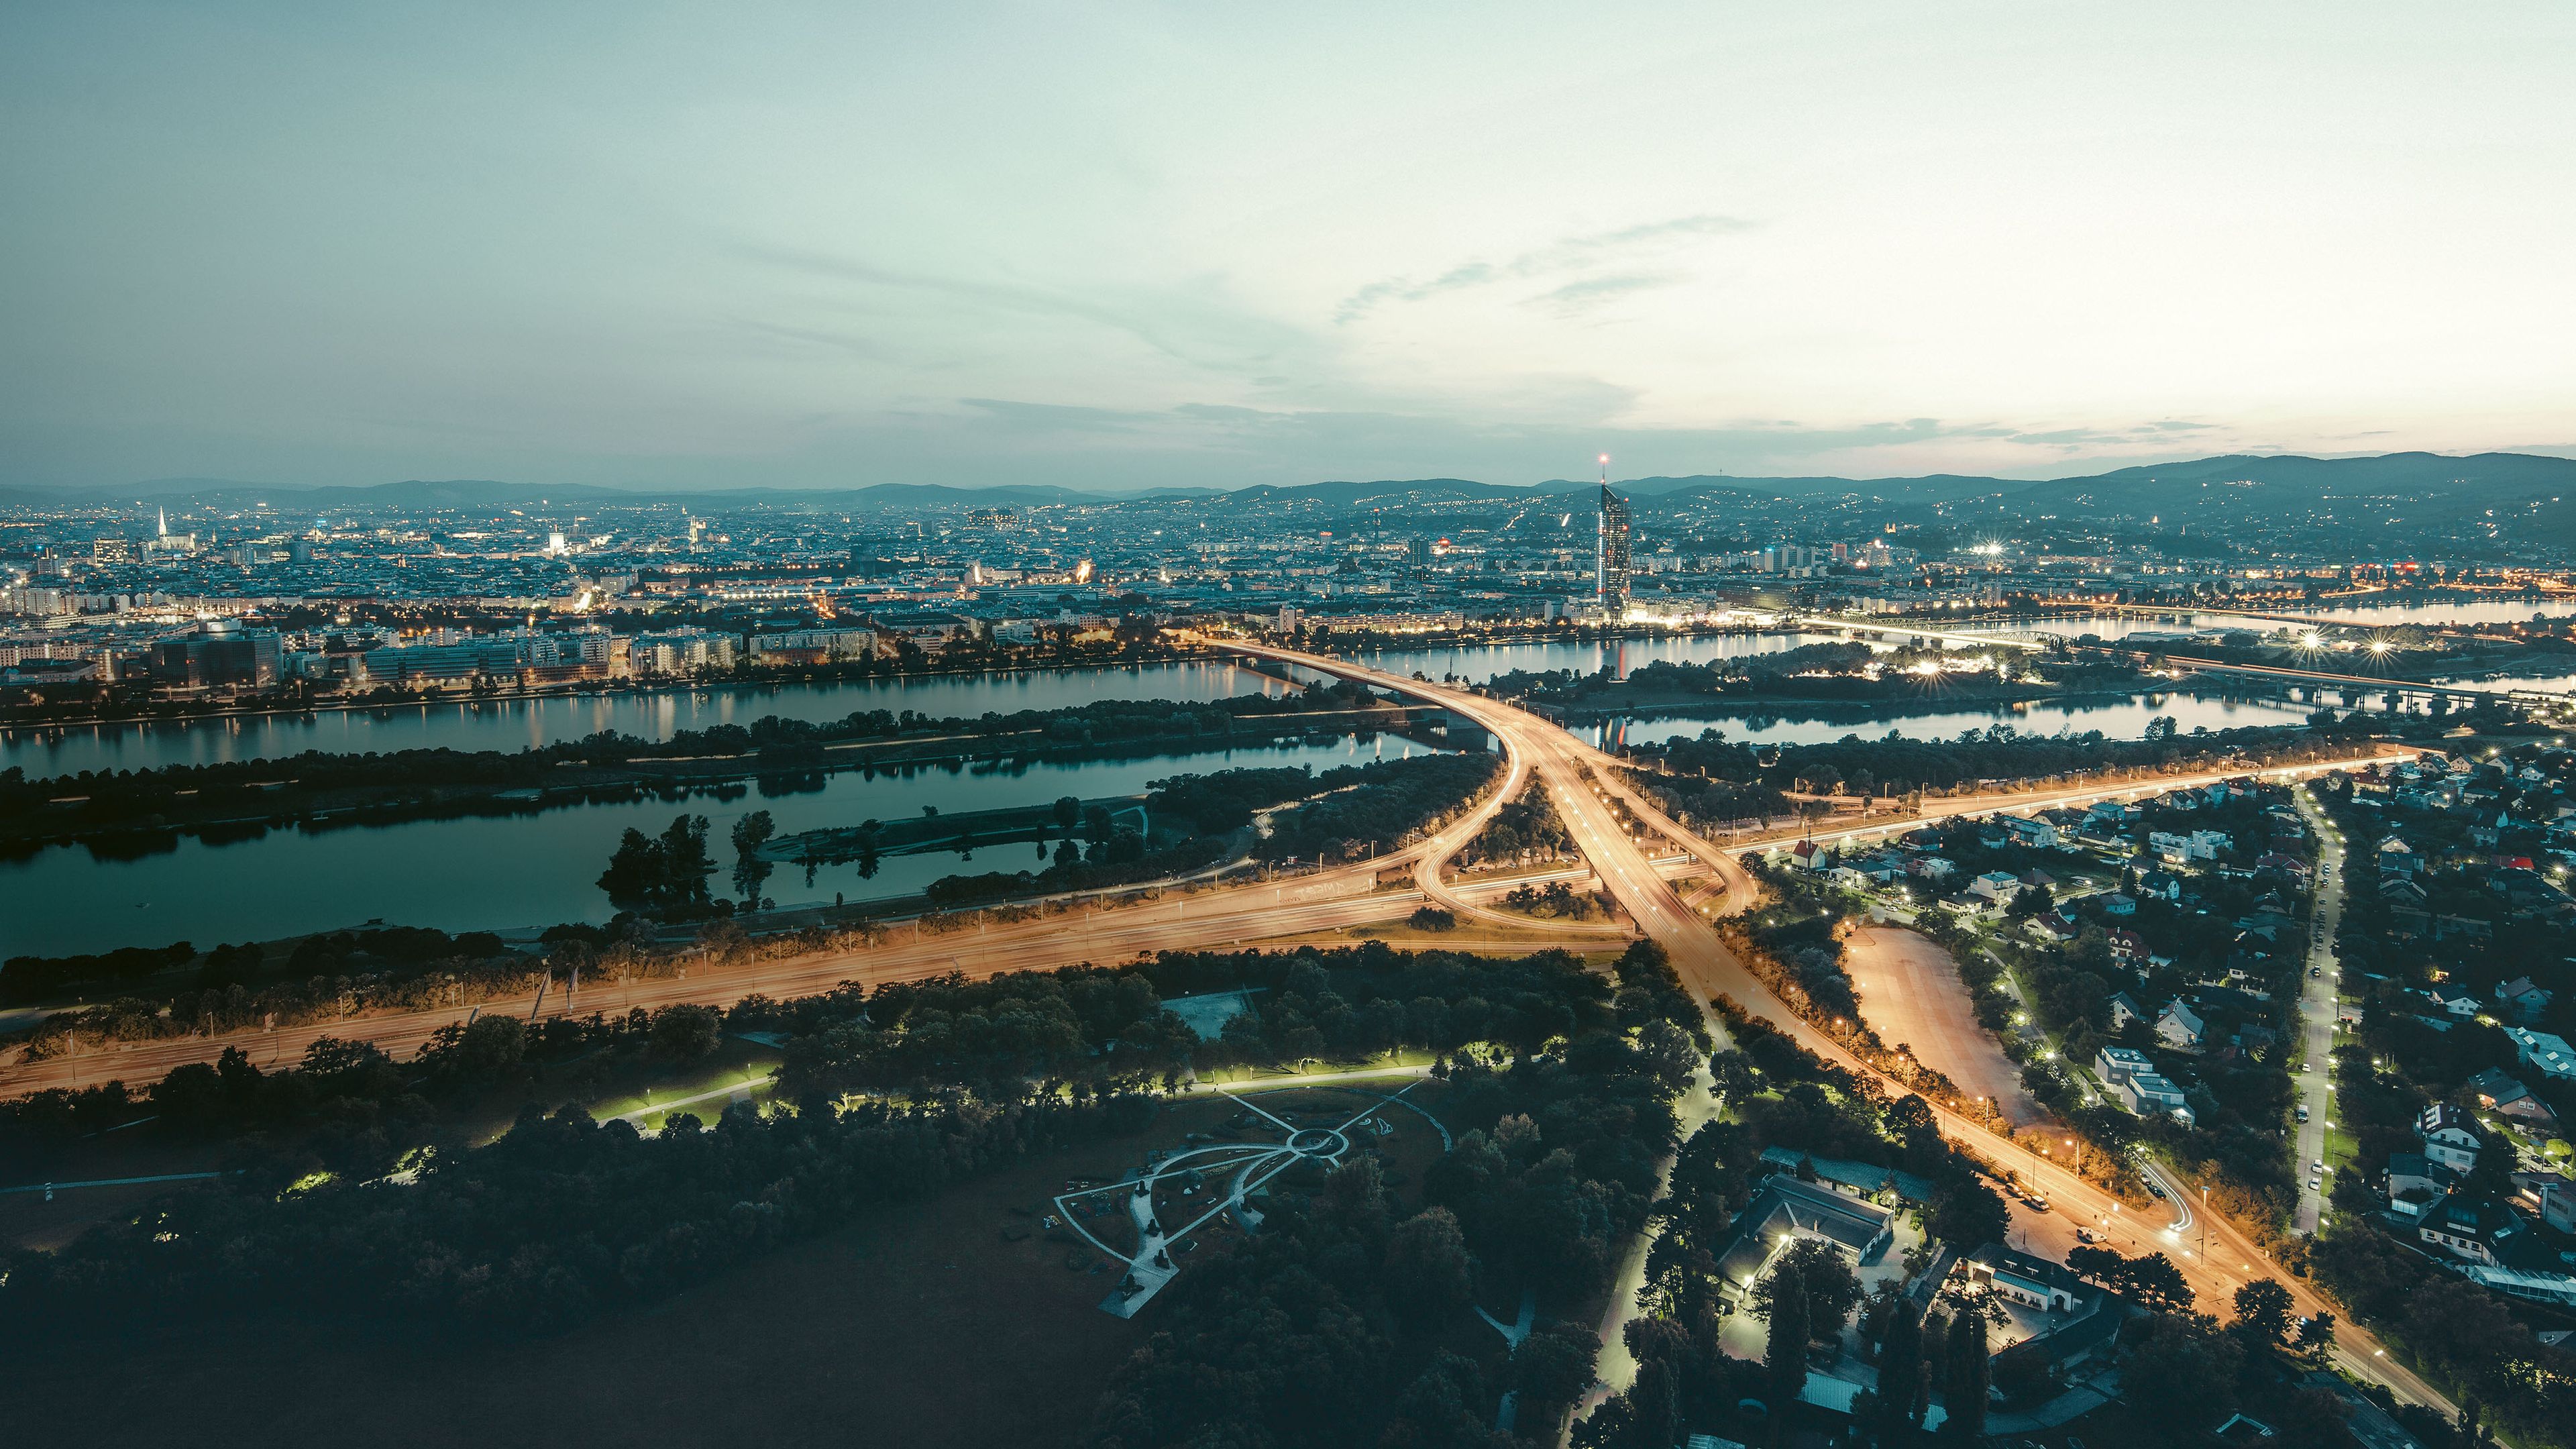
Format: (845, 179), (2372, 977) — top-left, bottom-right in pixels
(0, 0), (2576, 487)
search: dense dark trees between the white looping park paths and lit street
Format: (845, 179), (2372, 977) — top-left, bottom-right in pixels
(1089, 944), (1703, 1449)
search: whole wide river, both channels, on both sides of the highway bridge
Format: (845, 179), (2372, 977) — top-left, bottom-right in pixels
(0, 634), (2473, 959)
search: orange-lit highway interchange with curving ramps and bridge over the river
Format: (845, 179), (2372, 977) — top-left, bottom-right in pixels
(0, 645), (2447, 1408)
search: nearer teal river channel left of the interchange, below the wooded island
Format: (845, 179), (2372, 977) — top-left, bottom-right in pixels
(0, 735), (1430, 959)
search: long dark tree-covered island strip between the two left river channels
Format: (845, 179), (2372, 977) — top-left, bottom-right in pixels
(0, 686), (1411, 859)
